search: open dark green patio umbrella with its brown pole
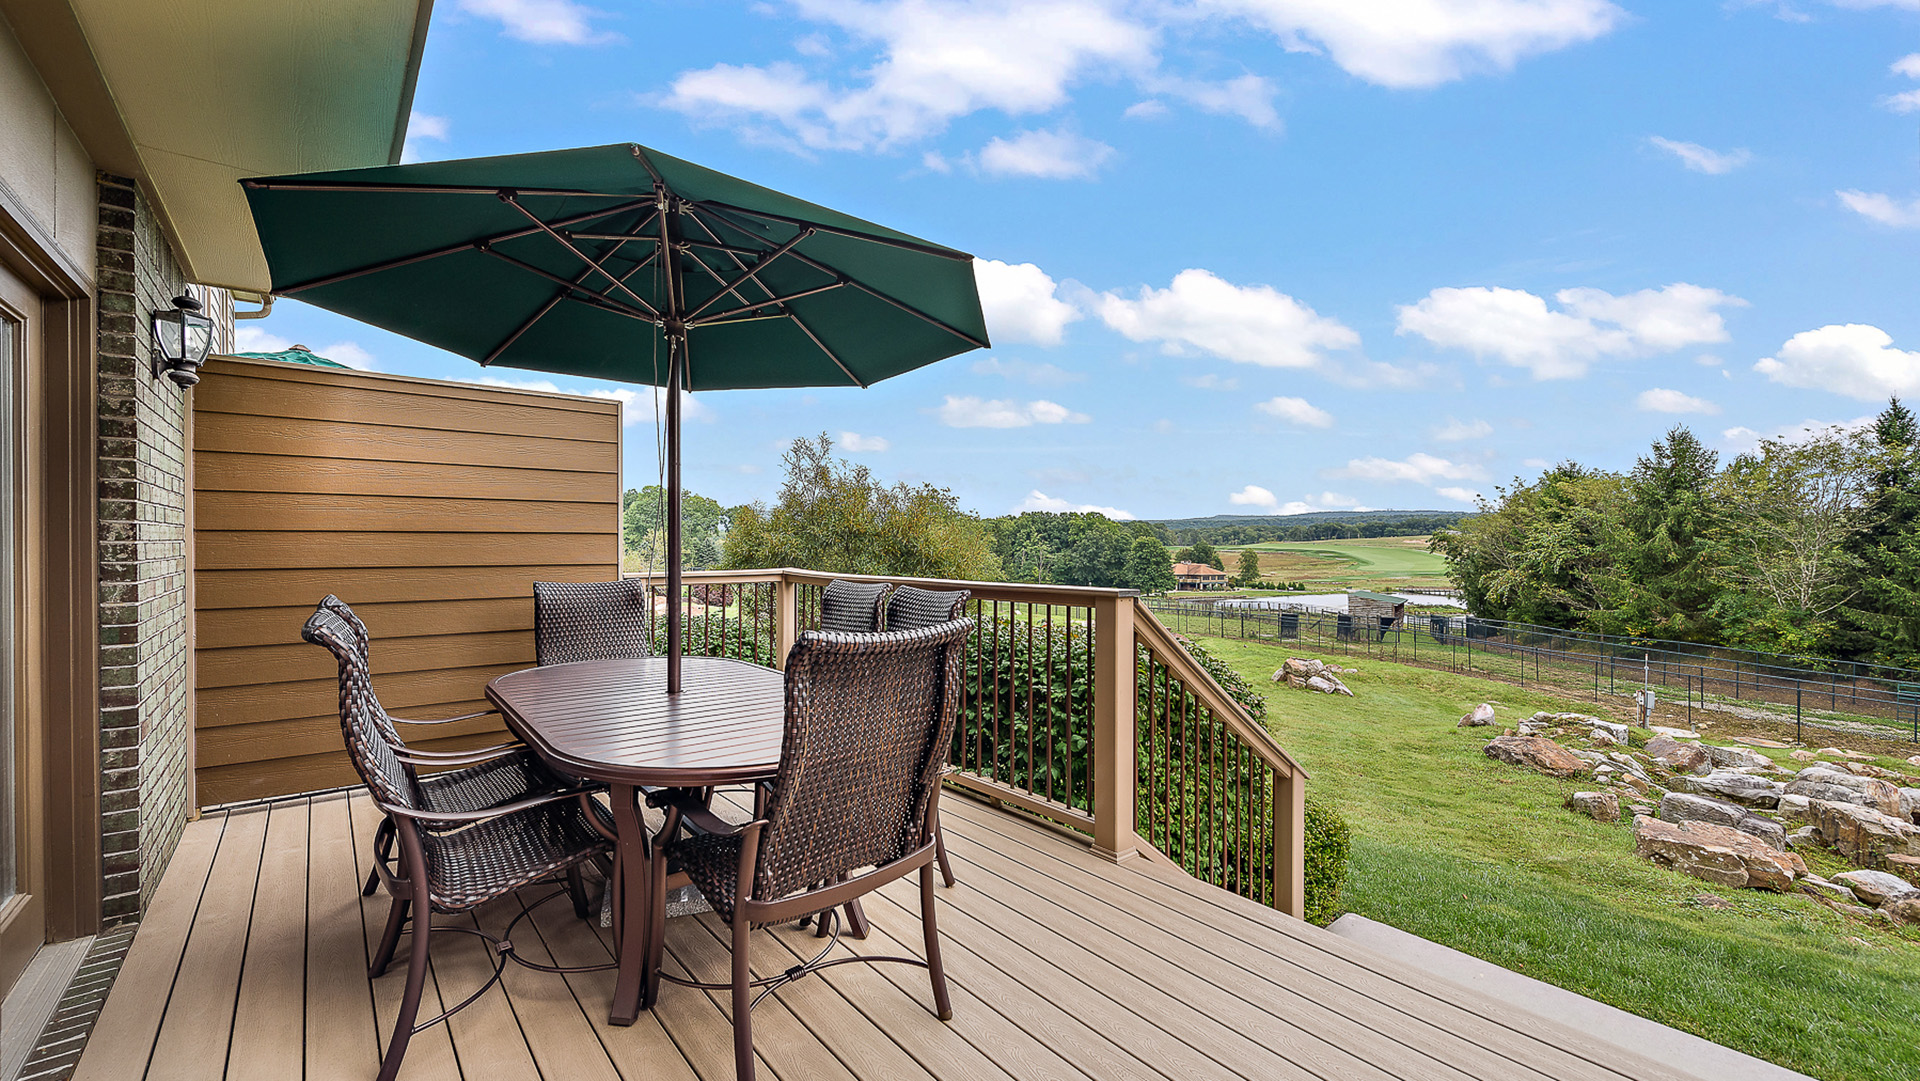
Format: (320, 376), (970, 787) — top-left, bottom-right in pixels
(242, 144), (987, 691)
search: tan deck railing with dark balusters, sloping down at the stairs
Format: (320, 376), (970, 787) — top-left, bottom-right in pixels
(630, 568), (1308, 916)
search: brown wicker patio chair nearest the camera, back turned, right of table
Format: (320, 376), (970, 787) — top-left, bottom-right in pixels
(664, 620), (973, 1081)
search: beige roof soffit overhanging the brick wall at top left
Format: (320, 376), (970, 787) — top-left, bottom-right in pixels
(6, 0), (432, 292)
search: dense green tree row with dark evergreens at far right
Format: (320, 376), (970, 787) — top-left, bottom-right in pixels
(1432, 399), (1920, 666)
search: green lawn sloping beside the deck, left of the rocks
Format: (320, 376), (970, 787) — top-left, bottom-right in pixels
(1204, 639), (1920, 1081)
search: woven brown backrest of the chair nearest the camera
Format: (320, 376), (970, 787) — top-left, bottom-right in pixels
(753, 620), (973, 901)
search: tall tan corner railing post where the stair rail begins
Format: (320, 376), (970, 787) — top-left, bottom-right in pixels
(1092, 597), (1139, 864)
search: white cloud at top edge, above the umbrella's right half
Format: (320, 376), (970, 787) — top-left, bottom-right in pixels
(660, 0), (1154, 150)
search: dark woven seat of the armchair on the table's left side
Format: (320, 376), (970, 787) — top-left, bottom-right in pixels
(420, 799), (612, 912)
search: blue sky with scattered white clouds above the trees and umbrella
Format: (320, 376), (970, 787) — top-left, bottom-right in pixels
(242, 0), (1920, 518)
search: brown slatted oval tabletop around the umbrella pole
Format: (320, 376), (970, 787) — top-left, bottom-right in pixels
(486, 657), (785, 787)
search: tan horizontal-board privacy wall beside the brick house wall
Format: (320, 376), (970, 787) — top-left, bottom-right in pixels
(194, 359), (620, 805)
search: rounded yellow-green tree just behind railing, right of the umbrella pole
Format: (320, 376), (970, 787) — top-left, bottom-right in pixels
(724, 432), (1000, 582)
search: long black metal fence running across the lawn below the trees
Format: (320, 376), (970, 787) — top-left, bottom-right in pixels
(1146, 599), (1920, 743)
